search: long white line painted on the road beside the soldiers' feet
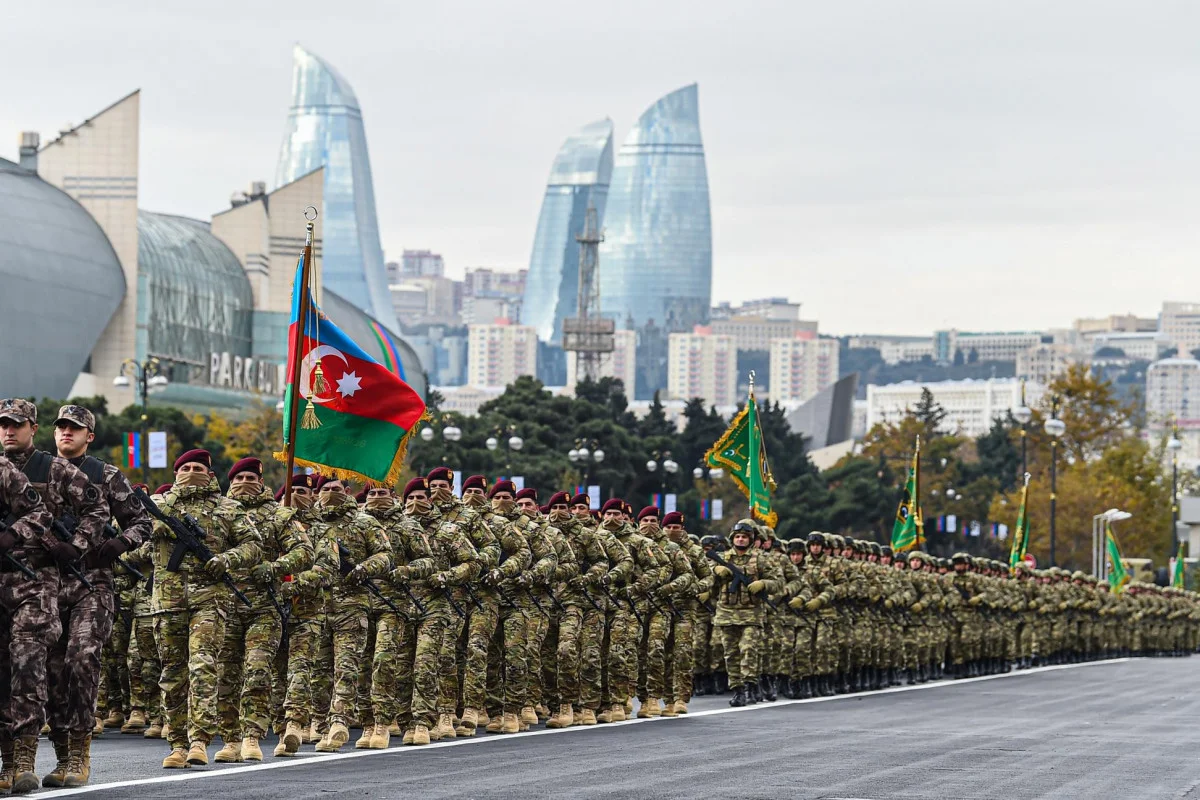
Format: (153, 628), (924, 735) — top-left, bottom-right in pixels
(37, 658), (1132, 798)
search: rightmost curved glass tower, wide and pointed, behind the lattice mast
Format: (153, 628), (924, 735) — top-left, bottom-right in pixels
(600, 84), (713, 398)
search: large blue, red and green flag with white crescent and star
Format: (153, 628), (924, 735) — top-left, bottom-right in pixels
(275, 257), (425, 486)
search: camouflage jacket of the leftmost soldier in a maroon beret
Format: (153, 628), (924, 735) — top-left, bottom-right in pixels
(150, 477), (263, 614)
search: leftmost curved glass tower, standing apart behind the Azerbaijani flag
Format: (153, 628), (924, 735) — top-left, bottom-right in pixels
(275, 44), (400, 330)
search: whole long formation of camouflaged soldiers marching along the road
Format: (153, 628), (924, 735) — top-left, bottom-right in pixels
(0, 399), (1200, 794)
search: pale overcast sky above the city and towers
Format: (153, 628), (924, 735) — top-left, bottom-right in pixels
(0, 0), (1200, 333)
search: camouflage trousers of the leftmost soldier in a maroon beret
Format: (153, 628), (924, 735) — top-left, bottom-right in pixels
(155, 600), (226, 748)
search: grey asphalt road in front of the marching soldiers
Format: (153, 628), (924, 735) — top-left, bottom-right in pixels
(38, 657), (1200, 800)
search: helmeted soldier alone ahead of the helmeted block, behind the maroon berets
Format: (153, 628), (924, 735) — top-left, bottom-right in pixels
(713, 519), (784, 708)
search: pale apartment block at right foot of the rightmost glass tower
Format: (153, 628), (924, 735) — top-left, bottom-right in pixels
(667, 325), (738, 405)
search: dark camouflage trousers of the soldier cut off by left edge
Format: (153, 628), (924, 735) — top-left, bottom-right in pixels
(0, 567), (62, 740)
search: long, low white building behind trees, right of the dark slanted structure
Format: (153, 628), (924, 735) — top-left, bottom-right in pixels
(866, 378), (1045, 437)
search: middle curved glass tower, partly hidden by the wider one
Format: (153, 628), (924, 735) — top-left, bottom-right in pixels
(521, 120), (612, 345)
